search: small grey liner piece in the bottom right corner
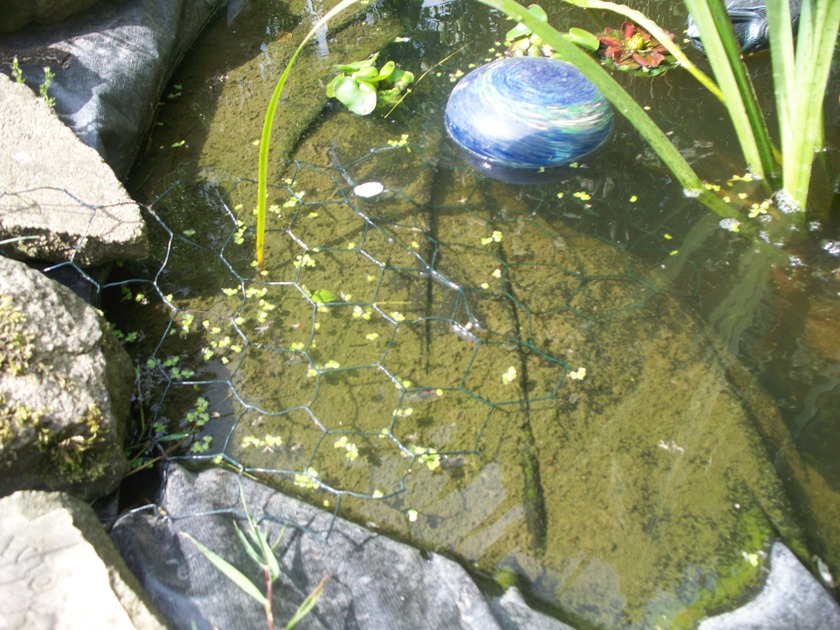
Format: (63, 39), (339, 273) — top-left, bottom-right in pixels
(700, 543), (840, 630)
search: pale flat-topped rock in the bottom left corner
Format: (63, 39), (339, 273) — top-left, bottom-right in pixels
(0, 491), (166, 630)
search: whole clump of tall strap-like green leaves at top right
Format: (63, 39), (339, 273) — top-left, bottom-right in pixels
(481, 0), (840, 225)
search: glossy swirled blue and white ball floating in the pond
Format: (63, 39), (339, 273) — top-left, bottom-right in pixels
(444, 57), (612, 176)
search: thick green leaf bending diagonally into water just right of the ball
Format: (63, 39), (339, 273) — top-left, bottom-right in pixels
(480, 0), (738, 218)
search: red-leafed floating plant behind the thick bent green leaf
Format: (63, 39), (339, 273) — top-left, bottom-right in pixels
(598, 22), (675, 75)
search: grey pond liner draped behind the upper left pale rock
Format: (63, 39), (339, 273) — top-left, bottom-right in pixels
(0, 0), (225, 179)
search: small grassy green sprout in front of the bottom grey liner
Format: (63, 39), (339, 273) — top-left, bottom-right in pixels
(184, 488), (329, 630)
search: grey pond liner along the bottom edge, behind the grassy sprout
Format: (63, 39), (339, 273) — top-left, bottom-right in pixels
(111, 464), (568, 630)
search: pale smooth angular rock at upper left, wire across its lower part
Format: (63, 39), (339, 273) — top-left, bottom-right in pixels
(0, 75), (149, 266)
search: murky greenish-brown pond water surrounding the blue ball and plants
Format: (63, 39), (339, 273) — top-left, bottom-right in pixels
(106, 0), (840, 627)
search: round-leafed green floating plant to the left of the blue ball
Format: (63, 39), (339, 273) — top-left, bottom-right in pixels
(326, 53), (414, 116)
